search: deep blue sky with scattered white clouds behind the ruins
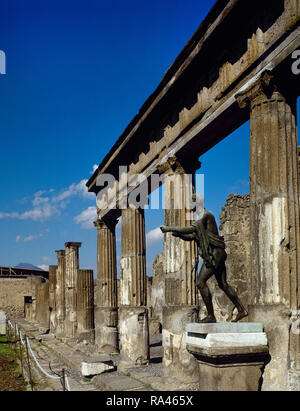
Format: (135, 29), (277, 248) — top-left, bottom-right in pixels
(0, 0), (298, 274)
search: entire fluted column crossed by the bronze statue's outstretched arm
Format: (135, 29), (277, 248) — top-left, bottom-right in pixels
(159, 157), (200, 383)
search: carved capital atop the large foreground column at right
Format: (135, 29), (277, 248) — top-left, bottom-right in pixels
(235, 70), (284, 109)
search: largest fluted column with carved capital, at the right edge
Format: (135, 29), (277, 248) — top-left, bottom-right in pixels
(237, 72), (300, 390)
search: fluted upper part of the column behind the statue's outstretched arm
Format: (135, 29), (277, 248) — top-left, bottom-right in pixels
(161, 157), (199, 305)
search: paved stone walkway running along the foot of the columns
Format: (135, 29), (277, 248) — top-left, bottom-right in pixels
(12, 319), (197, 391)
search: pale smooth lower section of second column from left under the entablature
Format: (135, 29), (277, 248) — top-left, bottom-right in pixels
(118, 306), (150, 371)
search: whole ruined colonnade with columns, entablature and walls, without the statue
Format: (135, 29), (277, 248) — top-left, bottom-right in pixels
(2, 0), (300, 390)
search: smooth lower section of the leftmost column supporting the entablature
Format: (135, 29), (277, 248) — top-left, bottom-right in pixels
(94, 307), (119, 353)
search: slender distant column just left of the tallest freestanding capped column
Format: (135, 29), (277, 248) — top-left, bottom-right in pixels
(55, 250), (66, 337)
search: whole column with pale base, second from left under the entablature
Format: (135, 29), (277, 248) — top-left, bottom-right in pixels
(119, 208), (149, 369)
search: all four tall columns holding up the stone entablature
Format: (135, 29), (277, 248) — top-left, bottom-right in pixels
(95, 72), (300, 389)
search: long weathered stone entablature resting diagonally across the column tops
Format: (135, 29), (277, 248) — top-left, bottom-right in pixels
(87, 0), (300, 225)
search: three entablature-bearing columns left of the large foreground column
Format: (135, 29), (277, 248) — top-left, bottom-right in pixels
(94, 158), (200, 381)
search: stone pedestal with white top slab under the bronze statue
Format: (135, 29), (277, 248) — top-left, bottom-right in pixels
(186, 323), (269, 391)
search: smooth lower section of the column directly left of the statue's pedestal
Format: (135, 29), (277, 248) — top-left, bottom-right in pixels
(162, 306), (199, 384)
